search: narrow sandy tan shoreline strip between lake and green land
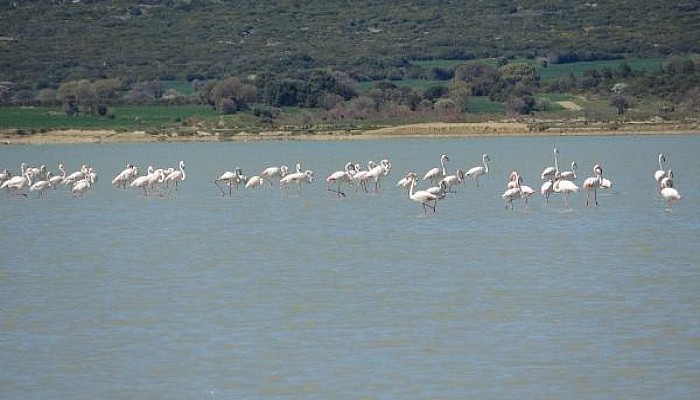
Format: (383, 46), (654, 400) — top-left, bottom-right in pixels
(0, 121), (700, 145)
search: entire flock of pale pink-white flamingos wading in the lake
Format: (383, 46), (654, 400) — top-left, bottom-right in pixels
(0, 147), (681, 215)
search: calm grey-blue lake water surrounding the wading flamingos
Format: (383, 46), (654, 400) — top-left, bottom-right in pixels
(0, 136), (700, 399)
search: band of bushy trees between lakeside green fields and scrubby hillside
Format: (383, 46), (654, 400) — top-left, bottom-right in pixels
(0, 57), (700, 121)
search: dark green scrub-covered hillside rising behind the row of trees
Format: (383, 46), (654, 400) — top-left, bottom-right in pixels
(0, 0), (700, 88)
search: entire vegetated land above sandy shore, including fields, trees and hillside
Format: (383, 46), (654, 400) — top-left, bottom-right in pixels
(0, 0), (700, 131)
